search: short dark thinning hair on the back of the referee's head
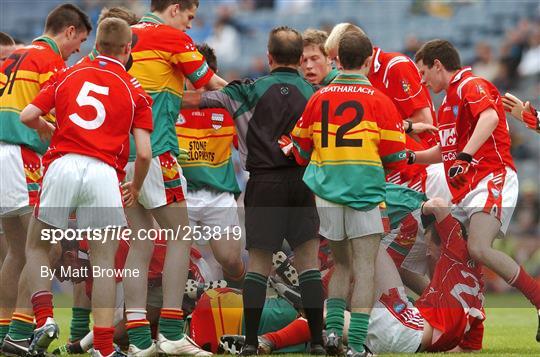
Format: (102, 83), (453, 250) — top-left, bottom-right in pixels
(268, 26), (304, 65)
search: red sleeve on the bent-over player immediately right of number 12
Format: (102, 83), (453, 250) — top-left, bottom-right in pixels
(387, 60), (431, 118)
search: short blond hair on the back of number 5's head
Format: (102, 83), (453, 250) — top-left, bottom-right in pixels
(96, 18), (131, 56)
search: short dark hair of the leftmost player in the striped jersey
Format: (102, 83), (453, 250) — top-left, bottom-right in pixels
(45, 4), (92, 35)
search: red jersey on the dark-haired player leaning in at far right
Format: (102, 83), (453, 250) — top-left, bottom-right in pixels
(438, 67), (515, 203)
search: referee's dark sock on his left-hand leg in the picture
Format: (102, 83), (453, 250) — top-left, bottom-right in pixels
(242, 272), (268, 346)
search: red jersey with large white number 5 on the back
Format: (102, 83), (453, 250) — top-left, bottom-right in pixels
(32, 56), (152, 180)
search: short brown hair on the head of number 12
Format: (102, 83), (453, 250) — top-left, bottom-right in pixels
(338, 32), (373, 70)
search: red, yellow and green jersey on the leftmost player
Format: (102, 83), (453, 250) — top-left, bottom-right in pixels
(0, 37), (65, 154)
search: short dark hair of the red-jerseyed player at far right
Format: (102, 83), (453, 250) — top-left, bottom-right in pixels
(414, 40), (461, 71)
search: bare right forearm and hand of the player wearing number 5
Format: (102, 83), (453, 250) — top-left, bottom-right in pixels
(122, 128), (152, 207)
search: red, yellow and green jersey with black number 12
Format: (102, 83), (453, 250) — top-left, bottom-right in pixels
(300, 75), (404, 209)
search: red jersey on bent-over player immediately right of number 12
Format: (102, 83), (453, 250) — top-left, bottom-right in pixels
(368, 47), (437, 184)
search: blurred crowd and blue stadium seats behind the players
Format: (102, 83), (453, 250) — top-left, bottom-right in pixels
(0, 0), (540, 291)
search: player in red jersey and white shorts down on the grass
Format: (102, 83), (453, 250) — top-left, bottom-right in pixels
(220, 198), (485, 354)
